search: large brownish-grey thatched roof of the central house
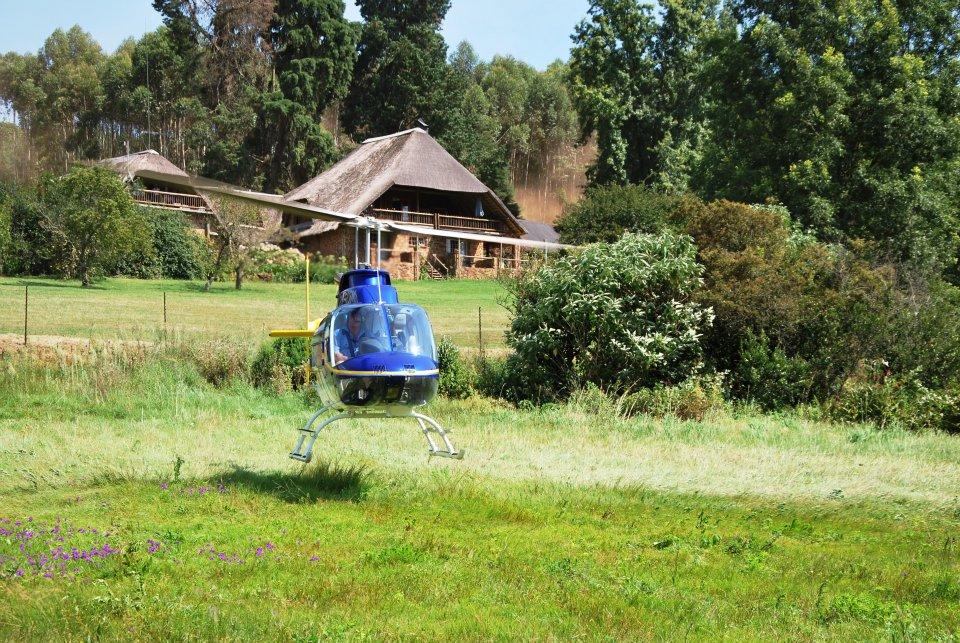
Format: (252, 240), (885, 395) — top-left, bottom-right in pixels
(284, 127), (516, 233)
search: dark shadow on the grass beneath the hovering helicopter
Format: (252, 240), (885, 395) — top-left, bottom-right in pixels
(218, 462), (368, 503)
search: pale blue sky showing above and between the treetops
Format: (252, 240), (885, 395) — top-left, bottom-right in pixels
(0, 0), (588, 69)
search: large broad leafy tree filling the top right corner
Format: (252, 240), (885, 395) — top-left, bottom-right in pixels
(703, 0), (960, 269)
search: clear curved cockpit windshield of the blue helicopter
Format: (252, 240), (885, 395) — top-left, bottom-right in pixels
(330, 304), (436, 364)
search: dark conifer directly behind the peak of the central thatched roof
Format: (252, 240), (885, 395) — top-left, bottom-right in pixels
(344, 0), (450, 138)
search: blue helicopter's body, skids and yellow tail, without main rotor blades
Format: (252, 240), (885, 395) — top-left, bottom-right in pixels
(270, 267), (463, 462)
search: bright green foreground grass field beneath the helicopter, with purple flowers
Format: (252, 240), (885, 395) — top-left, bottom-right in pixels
(0, 282), (960, 641)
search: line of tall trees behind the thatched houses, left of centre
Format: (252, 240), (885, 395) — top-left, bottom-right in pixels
(0, 0), (589, 218)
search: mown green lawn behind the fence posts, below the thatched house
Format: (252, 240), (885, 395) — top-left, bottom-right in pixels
(0, 278), (509, 347)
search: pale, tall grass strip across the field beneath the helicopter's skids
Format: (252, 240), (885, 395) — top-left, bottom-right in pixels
(0, 340), (960, 507)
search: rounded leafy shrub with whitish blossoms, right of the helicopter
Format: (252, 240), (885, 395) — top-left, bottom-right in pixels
(507, 233), (711, 400)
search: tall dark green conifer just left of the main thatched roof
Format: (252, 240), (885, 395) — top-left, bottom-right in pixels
(249, 0), (358, 191)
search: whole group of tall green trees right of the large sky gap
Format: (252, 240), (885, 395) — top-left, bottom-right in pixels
(570, 0), (960, 273)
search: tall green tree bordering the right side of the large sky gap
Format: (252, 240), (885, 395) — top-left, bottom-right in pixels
(570, 0), (716, 192)
